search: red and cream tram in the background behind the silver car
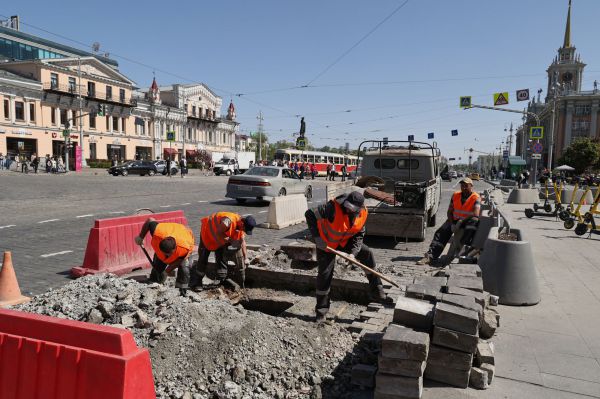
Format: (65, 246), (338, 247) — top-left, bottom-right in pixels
(275, 148), (358, 176)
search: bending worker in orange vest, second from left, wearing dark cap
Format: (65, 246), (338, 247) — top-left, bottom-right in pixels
(190, 212), (256, 289)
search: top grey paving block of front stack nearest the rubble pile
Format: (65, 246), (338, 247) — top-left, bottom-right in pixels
(381, 324), (429, 361)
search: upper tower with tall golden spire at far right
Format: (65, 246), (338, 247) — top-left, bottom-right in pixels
(546, 0), (585, 101)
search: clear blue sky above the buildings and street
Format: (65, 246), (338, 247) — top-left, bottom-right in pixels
(0, 0), (600, 160)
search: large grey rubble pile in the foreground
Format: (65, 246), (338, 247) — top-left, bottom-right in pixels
(16, 275), (366, 399)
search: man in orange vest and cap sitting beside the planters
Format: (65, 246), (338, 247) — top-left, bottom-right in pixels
(417, 177), (481, 265)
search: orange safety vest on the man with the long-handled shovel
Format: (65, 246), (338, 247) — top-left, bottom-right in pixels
(315, 200), (368, 249)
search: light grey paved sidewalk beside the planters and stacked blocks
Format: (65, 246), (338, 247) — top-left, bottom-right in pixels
(423, 204), (600, 399)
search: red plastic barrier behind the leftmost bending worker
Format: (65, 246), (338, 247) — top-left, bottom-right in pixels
(71, 211), (188, 277)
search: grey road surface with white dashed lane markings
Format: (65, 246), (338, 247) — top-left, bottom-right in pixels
(0, 170), (483, 295)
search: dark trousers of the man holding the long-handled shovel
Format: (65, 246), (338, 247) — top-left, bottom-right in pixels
(315, 244), (383, 316)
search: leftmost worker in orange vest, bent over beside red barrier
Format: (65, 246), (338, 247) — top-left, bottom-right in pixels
(135, 218), (194, 294)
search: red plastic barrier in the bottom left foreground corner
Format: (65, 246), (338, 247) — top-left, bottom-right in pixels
(0, 309), (156, 399)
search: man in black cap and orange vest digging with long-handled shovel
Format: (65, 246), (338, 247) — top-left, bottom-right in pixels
(304, 191), (392, 322)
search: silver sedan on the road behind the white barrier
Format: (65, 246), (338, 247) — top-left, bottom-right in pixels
(225, 166), (312, 204)
